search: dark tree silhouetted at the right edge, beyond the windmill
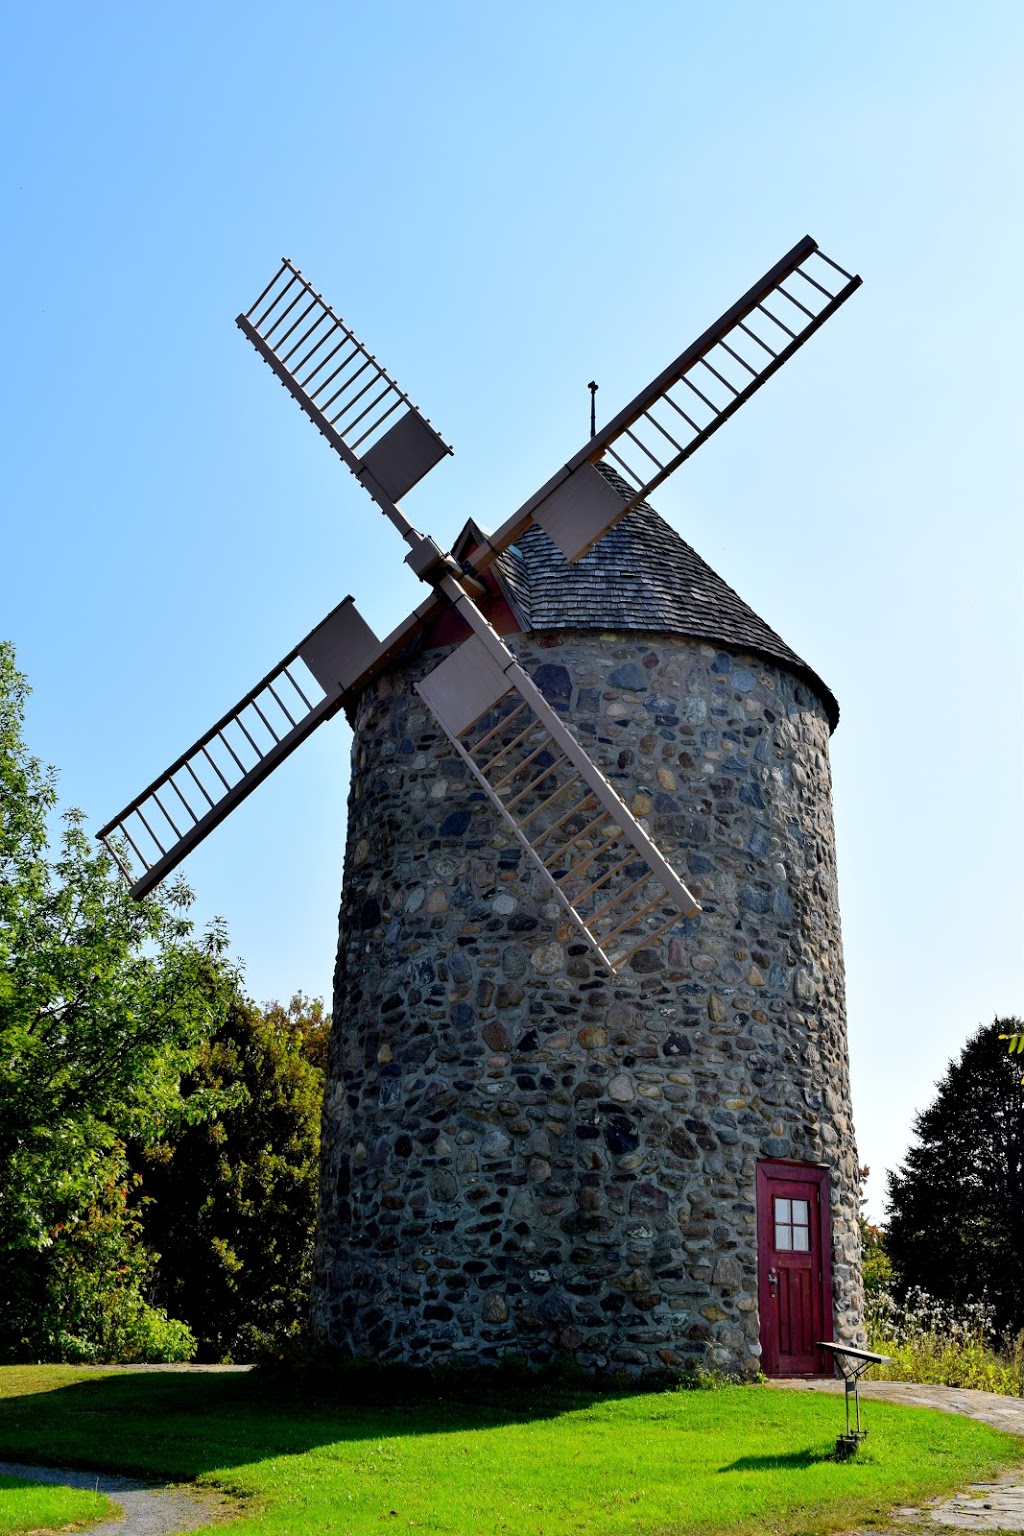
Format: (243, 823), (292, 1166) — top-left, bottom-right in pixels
(886, 1018), (1024, 1333)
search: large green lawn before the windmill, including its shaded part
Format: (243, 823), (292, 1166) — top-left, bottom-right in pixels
(0, 1366), (1024, 1536)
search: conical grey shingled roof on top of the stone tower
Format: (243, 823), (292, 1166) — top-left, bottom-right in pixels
(497, 502), (840, 730)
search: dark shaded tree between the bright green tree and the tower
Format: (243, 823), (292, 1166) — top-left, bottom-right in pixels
(135, 994), (327, 1359)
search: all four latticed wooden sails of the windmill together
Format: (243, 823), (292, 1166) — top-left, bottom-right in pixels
(98, 237), (861, 971)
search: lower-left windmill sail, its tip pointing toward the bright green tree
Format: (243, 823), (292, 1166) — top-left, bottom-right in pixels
(98, 598), (380, 900)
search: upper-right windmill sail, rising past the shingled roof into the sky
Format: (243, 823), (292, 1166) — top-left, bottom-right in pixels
(470, 235), (861, 571)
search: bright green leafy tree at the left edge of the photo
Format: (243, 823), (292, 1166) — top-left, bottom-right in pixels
(0, 642), (236, 1358)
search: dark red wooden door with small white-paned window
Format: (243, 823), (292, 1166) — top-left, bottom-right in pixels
(757, 1161), (832, 1376)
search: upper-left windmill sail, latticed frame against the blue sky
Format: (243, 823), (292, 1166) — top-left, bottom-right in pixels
(235, 257), (451, 513)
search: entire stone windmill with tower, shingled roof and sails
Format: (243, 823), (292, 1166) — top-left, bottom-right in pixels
(101, 240), (861, 1373)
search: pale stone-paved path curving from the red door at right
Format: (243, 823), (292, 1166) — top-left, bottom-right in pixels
(772, 1379), (1024, 1531)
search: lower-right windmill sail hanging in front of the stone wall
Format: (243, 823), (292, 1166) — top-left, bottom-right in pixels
(416, 584), (700, 971)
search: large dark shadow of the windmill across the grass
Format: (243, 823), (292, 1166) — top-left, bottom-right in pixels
(0, 1369), (649, 1481)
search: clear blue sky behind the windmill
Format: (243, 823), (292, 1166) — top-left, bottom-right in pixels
(0, 0), (1024, 1212)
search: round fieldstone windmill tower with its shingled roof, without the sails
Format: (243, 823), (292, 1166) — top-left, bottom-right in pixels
(313, 507), (863, 1375)
